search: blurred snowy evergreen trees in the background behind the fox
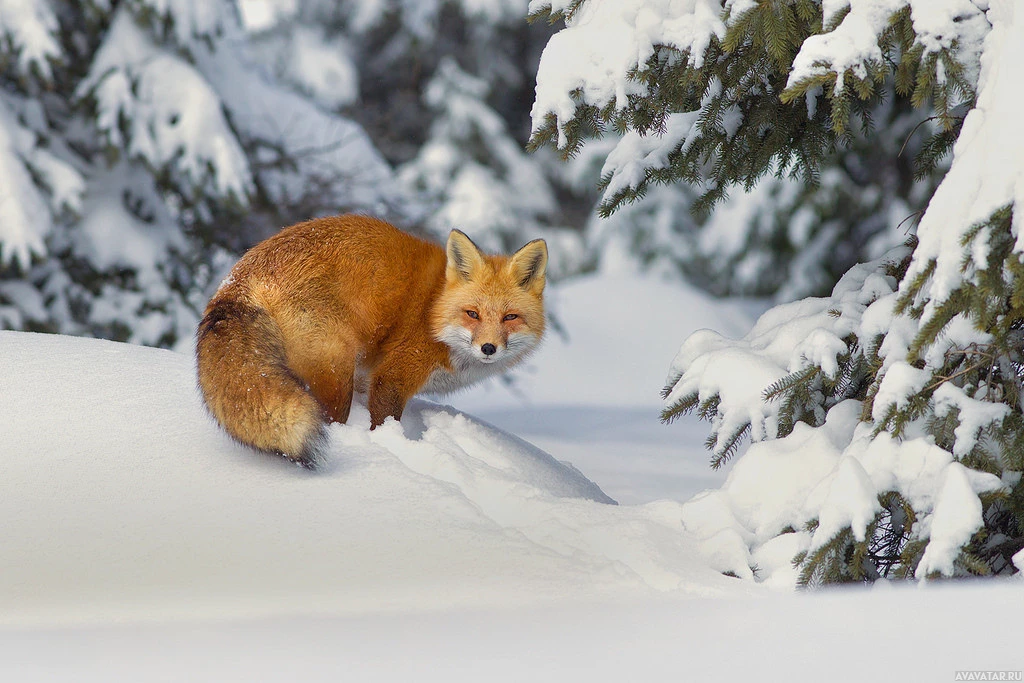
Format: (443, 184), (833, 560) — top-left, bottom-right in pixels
(0, 0), (942, 347)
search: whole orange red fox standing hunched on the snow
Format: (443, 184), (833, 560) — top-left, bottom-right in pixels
(196, 215), (548, 469)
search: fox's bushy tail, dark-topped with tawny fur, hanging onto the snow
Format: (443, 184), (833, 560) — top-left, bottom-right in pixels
(196, 299), (328, 469)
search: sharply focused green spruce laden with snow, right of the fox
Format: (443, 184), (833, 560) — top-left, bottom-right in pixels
(531, 0), (1024, 584)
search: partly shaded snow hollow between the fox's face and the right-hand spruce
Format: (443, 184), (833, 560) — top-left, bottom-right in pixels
(446, 273), (754, 504)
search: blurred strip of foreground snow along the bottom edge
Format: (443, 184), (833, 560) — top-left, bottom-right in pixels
(0, 581), (1024, 683)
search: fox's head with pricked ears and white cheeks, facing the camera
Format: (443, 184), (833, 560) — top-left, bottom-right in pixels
(433, 230), (548, 366)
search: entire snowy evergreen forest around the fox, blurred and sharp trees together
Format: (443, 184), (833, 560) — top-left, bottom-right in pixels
(0, 0), (1024, 583)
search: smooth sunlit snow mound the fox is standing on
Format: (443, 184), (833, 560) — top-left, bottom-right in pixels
(0, 332), (755, 625)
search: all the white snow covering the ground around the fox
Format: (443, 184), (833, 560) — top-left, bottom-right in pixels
(0, 275), (1024, 681)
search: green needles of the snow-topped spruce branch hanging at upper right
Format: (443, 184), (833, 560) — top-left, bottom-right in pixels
(529, 0), (974, 217)
